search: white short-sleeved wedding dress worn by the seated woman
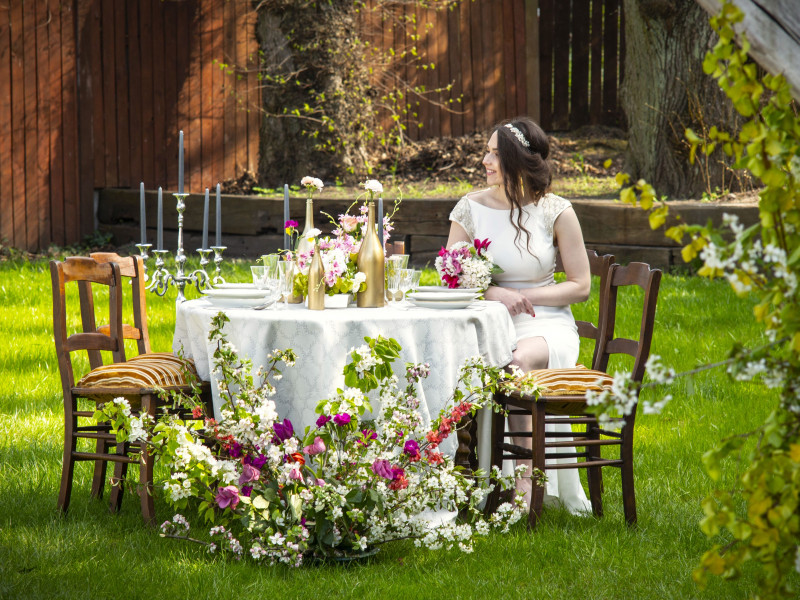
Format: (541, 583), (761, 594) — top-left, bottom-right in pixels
(450, 194), (591, 512)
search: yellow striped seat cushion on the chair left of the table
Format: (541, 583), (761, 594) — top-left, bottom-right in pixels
(76, 352), (197, 401)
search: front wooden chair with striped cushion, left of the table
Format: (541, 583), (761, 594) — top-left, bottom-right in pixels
(50, 257), (203, 523)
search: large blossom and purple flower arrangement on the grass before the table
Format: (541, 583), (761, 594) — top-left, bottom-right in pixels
(103, 313), (524, 566)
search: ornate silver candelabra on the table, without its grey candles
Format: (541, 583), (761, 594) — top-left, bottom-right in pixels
(136, 192), (227, 304)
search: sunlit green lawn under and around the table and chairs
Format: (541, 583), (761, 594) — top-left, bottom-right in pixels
(0, 255), (788, 599)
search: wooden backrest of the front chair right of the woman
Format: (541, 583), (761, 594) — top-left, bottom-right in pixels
(594, 262), (662, 382)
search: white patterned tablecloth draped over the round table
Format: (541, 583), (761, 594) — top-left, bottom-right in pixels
(173, 300), (515, 464)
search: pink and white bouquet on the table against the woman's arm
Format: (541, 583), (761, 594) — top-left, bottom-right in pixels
(434, 239), (503, 290)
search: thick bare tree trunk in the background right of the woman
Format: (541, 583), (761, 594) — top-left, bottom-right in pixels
(621, 0), (742, 198)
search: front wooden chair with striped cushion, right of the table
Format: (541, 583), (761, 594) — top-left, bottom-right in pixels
(487, 263), (661, 527)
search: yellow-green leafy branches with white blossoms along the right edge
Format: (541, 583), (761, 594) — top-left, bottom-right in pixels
(622, 1), (800, 598)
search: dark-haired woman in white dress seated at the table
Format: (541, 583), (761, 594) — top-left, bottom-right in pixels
(447, 117), (591, 512)
